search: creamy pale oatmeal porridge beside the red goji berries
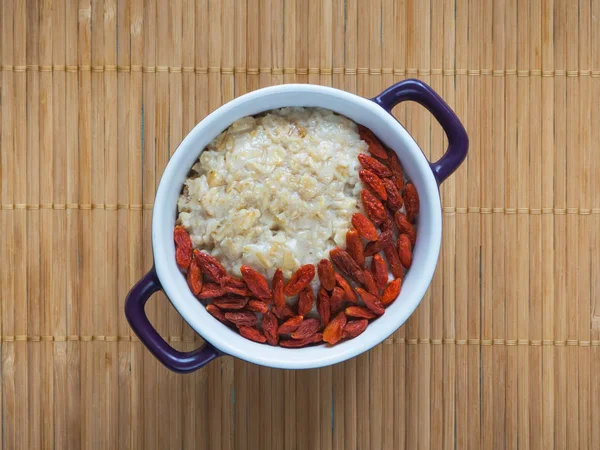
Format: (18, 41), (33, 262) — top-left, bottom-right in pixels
(178, 107), (367, 277)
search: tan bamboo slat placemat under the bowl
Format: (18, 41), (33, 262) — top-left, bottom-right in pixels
(0, 0), (600, 450)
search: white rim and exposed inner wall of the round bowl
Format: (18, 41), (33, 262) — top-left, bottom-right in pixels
(152, 85), (442, 369)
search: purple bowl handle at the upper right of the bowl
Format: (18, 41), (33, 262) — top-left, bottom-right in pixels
(373, 79), (469, 184)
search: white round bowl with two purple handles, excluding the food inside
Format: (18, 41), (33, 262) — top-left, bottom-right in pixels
(126, 80), (467, 372)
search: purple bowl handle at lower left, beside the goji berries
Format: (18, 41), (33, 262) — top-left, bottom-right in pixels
(125, 267), (221, 373)
